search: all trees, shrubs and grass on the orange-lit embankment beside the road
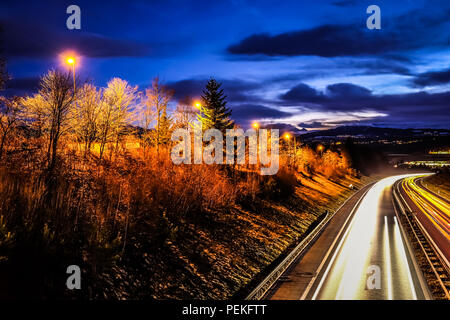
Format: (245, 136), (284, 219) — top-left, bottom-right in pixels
(0, 66), (370, 299)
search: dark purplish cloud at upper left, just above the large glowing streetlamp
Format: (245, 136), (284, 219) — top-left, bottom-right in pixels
(0, 20), (156, 58)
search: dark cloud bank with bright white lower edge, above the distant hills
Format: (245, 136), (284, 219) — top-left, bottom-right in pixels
(279, 83), (450, 127)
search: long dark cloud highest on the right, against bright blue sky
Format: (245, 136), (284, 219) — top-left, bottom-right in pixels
(227, 7), (450, 57)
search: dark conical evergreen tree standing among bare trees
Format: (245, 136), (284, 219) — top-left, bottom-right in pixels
(198, 79), (234, 132)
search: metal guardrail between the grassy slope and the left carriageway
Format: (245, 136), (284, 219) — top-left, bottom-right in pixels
(245, 183), (373, 300)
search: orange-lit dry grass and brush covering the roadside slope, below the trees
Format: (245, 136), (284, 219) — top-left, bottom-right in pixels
(0, 138), (360, 299)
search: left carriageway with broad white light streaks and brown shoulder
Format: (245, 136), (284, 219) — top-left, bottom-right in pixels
(268, 174), (430, 300)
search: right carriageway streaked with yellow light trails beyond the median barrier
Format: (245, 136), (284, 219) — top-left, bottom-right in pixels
(400, 176), (450, 266)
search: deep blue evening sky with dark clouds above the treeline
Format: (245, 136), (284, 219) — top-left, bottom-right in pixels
(0, 0), (450, 129)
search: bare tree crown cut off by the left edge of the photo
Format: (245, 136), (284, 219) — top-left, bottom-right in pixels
(0, 97), (22, 159)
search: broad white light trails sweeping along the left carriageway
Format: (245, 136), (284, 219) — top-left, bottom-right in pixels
(311, 174), (427, 300)
